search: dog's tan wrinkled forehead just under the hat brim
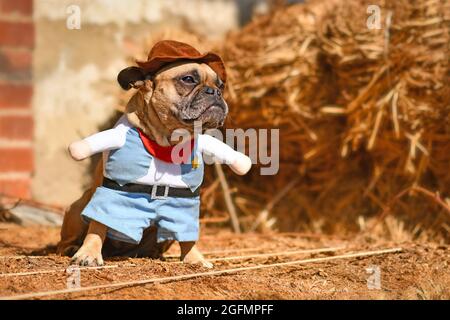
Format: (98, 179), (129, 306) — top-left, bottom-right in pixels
(154, 61), (223, 88)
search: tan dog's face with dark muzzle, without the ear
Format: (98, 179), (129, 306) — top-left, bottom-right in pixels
(151, 63), (228, 129)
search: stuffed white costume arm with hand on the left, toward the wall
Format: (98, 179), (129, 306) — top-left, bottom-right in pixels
(69, 123), (129, 161)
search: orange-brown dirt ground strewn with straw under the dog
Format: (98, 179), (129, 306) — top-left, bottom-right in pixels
(0, 223), (450, 299)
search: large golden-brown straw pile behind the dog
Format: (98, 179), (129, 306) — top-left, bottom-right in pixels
(210, 0), (450, 238)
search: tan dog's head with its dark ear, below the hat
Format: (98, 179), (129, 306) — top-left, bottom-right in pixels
(118, 62), (228, 132)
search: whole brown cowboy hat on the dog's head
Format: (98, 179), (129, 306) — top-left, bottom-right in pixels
(136, 40), (227, 83)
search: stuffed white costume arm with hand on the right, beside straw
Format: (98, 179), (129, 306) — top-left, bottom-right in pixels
(198, 134), (252, 175)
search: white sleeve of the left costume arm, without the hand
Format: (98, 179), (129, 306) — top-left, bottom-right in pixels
(84, 117), (130, 154)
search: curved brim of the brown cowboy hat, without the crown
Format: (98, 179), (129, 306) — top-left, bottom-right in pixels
(136, 52), (227, 83)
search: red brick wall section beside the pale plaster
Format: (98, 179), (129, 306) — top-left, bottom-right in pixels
(0, 0), (34, 198)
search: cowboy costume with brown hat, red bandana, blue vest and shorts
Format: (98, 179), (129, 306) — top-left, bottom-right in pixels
(82, 41), (246, 244)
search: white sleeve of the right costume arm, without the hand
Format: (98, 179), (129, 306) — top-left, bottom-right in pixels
(197, 134), (240, 164)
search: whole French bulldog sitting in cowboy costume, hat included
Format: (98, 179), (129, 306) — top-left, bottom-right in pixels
(57, 40), (251, 268)
